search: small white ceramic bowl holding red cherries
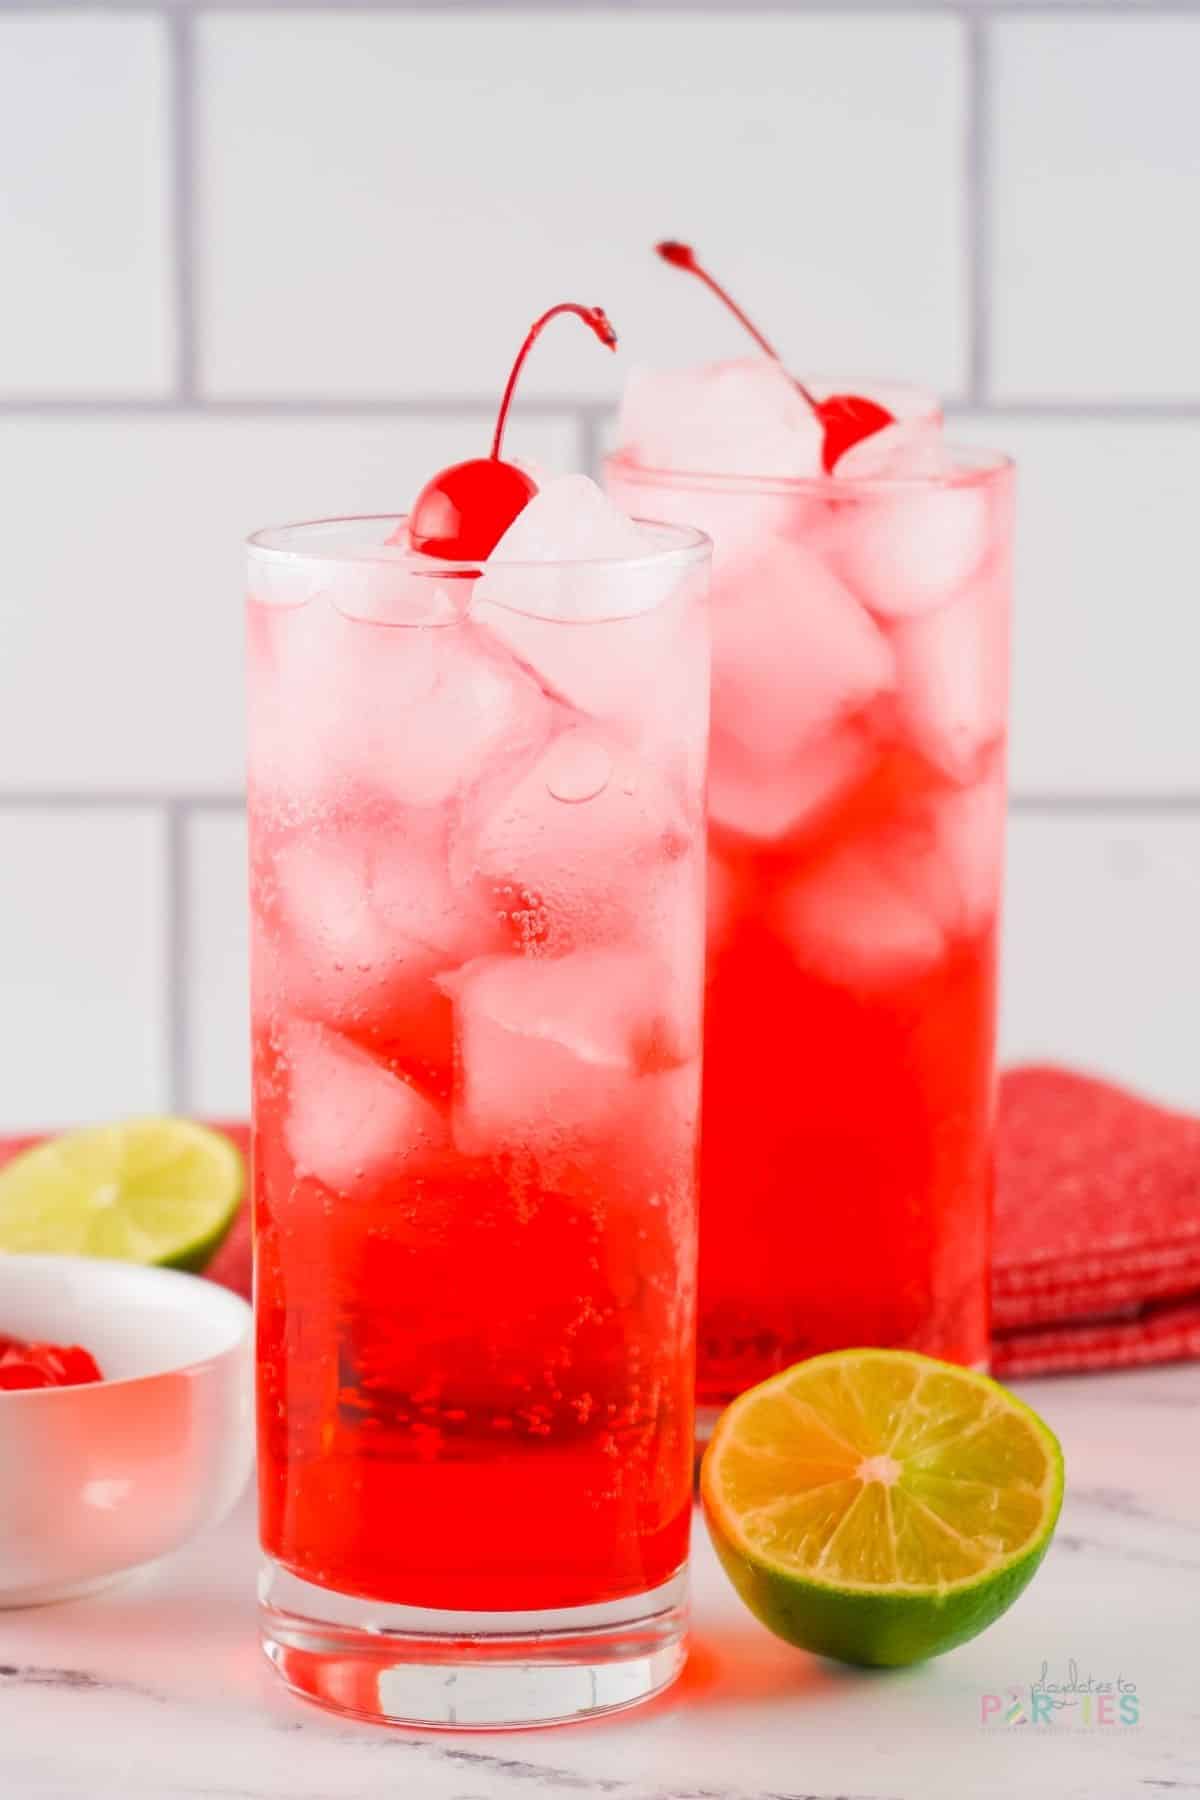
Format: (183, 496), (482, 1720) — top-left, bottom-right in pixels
(0, 1256), (254, 1606)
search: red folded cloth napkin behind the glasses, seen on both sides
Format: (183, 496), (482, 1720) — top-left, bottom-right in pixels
(0, 1067), (1200, 1377)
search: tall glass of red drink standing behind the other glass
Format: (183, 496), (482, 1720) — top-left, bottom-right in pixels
(608, 452), (1013, 1408)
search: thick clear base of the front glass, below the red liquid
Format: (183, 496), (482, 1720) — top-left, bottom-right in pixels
(259, 1557), (687, 1732)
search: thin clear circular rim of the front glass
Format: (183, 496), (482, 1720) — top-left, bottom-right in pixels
(245, 513), (712, 580)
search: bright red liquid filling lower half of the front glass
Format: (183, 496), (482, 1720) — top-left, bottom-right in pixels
(254, 957), (696, 1611)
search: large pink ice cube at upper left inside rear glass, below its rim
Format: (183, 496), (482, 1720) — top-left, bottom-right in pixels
(712, 544), (894, 761)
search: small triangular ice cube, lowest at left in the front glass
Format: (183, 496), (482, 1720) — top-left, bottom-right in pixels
(284, 1019), (446, 1193)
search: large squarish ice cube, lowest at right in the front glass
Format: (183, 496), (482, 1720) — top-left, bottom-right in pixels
(443, 950), (698, 1156)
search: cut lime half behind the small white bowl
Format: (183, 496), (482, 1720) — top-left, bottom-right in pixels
(0, 1118), (246, 1269)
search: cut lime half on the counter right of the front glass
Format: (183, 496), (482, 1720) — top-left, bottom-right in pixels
(700, 1350), (1063, 1667)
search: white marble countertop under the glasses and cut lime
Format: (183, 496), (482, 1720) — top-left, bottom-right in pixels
(0, 1366), (1200, 1800)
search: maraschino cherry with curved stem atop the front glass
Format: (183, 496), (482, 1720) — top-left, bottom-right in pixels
(408, 301), (617, 562)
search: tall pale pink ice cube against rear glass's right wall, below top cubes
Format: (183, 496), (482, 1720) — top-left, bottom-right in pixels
(892, 572), (1007, 781)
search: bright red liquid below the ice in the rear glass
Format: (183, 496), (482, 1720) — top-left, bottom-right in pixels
(698, 723), (999, 1406)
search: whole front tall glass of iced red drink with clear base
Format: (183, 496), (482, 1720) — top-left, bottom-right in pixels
(248, 518), (709, 1726)
